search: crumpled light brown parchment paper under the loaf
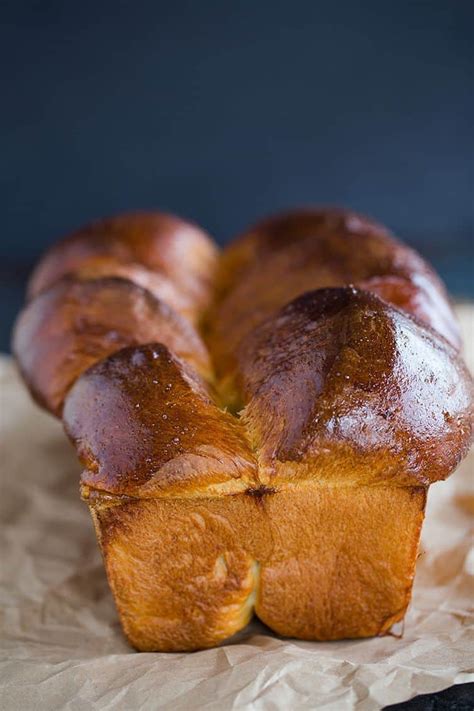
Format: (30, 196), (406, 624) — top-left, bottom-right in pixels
(0, 305), (474, 711)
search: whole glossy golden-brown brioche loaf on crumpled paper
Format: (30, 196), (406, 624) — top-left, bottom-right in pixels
(13, 209), (473, 651)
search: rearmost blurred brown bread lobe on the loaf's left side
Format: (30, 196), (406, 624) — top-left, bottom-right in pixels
(28, 212), (217, 322)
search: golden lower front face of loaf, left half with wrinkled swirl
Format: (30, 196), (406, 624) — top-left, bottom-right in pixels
(91, 496), (258, 652)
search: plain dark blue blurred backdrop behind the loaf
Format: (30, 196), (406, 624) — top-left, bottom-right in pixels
(0, 0), (474, 350)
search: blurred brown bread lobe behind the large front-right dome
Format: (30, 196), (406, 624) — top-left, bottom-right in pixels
(208, 209), (460, 376)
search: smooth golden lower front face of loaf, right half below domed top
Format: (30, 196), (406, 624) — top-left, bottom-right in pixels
(255, 486), (426, 640)
